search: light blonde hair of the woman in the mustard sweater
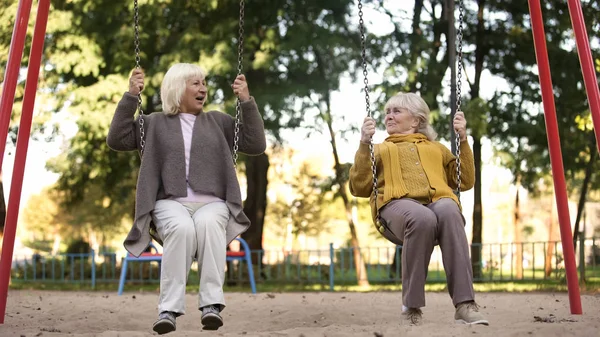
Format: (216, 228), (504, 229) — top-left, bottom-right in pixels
(385, 92), (437, 141)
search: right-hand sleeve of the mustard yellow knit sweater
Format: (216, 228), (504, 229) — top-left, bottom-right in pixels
(440, 141), (475, 191)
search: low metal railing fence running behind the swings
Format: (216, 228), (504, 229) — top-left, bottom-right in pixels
(12, 238), (600, 290)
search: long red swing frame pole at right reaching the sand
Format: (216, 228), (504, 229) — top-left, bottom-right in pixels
(528, 0), (582, 315)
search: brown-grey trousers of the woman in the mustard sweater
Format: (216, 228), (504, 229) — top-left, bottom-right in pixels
(380, 198), (475, 308)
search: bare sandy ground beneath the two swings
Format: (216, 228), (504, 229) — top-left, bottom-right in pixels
(0, 290), (600, 337)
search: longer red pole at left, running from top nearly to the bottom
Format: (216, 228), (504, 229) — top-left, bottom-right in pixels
(0, 0), (50, 324)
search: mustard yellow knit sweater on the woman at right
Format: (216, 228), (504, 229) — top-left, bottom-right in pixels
(350, 133), (475, 222)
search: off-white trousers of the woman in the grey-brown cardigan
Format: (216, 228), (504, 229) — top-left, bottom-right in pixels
(153, 200), (229, 315)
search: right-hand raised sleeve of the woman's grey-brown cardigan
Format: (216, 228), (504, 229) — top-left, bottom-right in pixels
(233, 97), (267, 156)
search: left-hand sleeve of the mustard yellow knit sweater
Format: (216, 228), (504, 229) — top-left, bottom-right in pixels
(349, 142), (373, 198)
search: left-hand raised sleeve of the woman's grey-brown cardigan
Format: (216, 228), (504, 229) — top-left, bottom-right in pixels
(106, 92), (139, 151)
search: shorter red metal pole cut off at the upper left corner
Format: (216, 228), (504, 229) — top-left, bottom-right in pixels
(0, 0), (32, 171)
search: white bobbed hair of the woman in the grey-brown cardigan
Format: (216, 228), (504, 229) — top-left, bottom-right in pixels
(160, 63), (206, 115)
